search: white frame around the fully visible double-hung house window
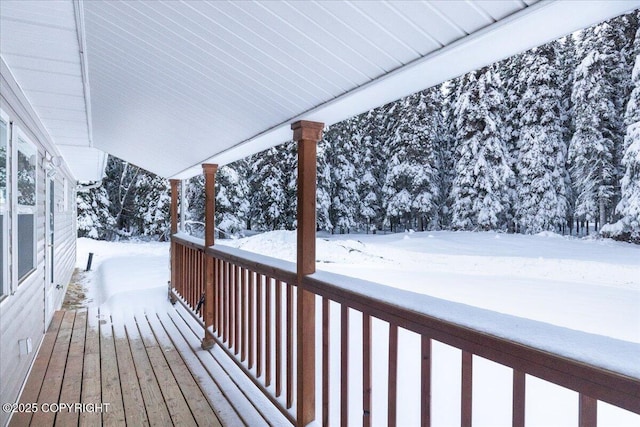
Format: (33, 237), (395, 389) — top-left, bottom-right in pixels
(11, 123), (40, 287)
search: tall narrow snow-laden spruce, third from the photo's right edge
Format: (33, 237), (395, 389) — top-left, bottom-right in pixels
(516, 43), (567, 233)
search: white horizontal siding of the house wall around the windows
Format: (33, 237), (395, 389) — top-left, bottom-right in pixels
(0, 60), (76, 425)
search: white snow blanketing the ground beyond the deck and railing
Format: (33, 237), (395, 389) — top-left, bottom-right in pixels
(78, 231), (640, 426)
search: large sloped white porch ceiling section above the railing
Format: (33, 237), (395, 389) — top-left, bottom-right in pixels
(2, 0), (640, 178)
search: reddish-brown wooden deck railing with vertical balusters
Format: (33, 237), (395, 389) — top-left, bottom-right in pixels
(172, 235), (640, 426)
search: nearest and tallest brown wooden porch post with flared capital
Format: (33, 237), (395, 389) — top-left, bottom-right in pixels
(291, 120), (324, 426)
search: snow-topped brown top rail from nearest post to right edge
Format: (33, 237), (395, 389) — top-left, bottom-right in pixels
(303, 272), (640, 413)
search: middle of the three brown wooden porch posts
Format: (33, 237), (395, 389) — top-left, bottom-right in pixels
(202, 164), (218, 350)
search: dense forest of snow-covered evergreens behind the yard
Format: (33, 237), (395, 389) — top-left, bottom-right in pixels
(78, 10), (640, 241)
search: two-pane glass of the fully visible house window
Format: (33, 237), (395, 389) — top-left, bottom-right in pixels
(17, 137), (38, 283)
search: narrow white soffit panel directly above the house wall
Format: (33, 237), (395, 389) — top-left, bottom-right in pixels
(0, 0), (104, 180)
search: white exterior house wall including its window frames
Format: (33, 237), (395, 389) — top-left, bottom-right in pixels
(0, 61), (76, 426)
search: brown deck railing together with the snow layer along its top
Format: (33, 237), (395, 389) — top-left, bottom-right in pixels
(172, 235), (640, 426)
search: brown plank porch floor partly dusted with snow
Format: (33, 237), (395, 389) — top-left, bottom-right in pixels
(9, 304), (290, 426)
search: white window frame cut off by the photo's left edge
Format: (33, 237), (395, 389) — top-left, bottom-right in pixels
(0, 109), (8, 301)
